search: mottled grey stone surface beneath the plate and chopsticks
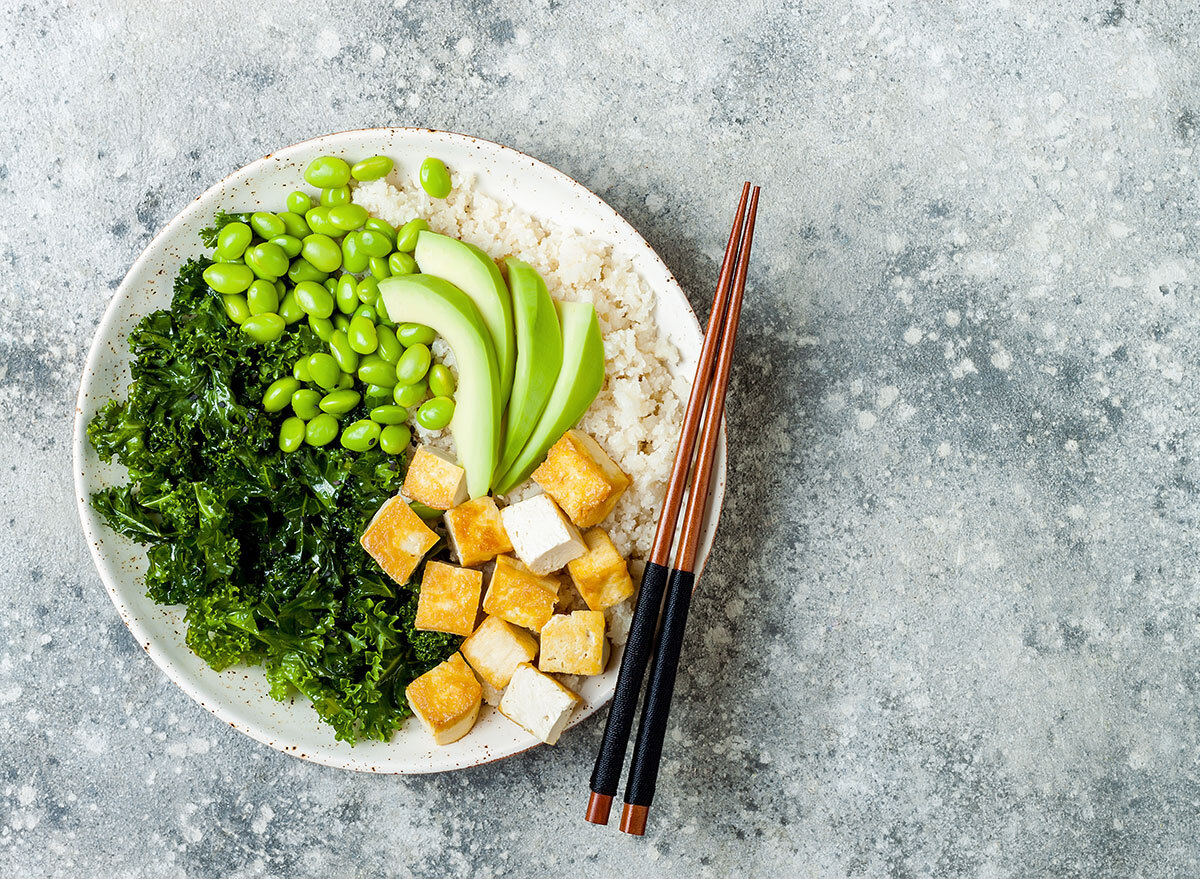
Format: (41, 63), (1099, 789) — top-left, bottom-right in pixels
(0, 0), (1200, 879)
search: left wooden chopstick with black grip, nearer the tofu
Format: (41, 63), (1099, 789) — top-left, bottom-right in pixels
(587, 183), (750, 824)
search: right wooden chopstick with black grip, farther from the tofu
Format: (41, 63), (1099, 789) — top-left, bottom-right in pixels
(620, 186), (758, 836)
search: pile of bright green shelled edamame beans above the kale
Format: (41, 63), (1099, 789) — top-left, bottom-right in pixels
(204, 156), (455, 455)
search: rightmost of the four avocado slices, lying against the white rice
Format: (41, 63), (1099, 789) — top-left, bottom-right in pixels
(492, 300), (604, 495)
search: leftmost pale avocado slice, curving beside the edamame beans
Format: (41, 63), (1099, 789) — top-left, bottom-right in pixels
(379, 275), (502, 498)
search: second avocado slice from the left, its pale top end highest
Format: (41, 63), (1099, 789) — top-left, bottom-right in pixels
(415, 232), (516, 409)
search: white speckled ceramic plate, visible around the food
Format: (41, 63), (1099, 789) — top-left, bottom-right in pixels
(74, 128), (725, 772)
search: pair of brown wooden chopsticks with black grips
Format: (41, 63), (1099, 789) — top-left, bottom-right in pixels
(587, 183), (758, 836)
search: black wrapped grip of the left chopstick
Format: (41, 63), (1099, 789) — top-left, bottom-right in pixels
(592, 562), (667, 796)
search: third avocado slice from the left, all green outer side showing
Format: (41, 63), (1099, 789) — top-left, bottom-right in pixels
(496, 257), (563, 476)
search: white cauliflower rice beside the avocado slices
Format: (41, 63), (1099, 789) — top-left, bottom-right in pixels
(354, 172), (689, 558)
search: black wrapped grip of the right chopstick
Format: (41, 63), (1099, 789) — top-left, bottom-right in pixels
(625, 570), (696, 806)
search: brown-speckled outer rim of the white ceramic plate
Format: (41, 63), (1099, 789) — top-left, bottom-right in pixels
(72, 126), (726, 775)
